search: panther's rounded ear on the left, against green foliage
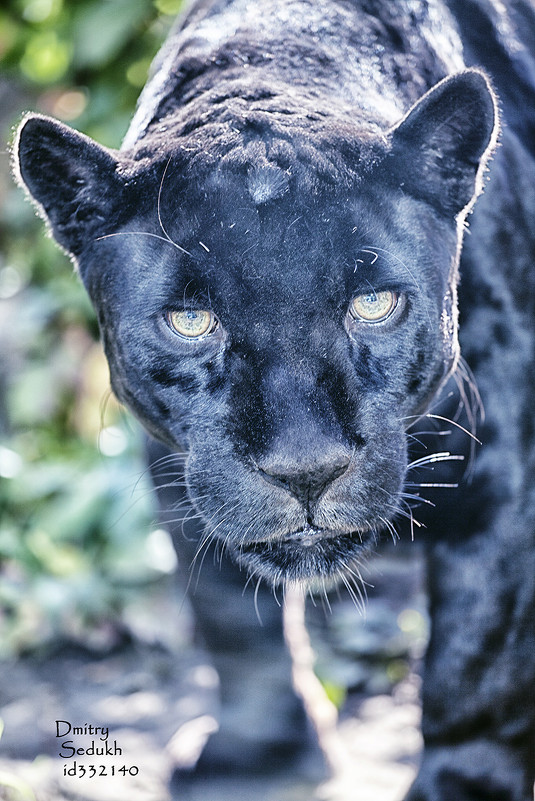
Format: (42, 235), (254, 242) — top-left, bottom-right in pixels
(13, 114), (123, 256)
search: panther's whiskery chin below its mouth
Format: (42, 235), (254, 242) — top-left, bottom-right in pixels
(233, 526), (373, 589)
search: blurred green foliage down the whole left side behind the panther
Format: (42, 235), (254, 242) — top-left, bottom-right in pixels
(0, 0), (185, 656)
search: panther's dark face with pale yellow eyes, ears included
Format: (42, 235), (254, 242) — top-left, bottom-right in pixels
(13, 73), (498, 583)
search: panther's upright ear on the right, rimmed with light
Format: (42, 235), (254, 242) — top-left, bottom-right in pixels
(389, 69), (498, 216)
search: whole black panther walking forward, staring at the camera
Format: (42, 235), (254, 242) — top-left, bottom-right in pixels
(11, 0), (535, 801)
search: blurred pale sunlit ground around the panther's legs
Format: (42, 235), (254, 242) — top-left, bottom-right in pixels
(0, 553), (425, 801)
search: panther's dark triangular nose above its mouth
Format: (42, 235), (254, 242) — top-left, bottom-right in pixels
(258, 449), (351, 507)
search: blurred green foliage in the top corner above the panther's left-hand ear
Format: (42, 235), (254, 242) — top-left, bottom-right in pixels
(0, 0), (182, 147)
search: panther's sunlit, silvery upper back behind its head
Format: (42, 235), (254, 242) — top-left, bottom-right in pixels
(123, 0), (463, 149)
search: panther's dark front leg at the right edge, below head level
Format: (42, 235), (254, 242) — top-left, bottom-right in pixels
(408, 515), (535, 801)
